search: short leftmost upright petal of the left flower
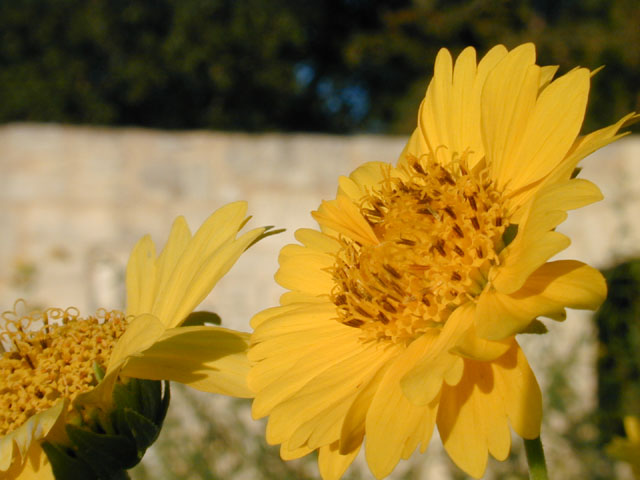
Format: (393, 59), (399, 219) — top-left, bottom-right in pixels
(126, 235), (156, 315)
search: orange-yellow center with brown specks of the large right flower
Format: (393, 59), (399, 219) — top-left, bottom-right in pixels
(332, 156), (507, 344)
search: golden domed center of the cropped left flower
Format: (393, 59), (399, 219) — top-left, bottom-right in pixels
(0, 308), (127, 435)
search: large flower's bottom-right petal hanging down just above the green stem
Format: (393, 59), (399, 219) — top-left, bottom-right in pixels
(491, 342), (542, 439)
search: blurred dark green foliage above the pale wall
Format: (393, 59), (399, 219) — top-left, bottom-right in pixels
(0, 0), (640, 134)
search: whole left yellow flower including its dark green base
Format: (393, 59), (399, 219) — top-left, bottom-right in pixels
(0, 202), (265, 479)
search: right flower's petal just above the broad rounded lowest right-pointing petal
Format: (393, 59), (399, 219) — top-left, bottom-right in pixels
(489, 178), (602, 293)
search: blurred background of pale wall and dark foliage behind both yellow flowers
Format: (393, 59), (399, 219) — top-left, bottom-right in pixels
(0, 0), (640, 480)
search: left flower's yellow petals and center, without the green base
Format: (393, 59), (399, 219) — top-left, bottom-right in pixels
(0, 202), (264, 479)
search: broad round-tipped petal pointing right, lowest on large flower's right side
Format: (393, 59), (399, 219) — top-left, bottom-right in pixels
(475, 260), (607, 340)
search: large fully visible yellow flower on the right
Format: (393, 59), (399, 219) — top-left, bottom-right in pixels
(249, 44), (633, 479)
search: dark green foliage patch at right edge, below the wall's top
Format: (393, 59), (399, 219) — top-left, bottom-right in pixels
(596, 259), (640, 444)
